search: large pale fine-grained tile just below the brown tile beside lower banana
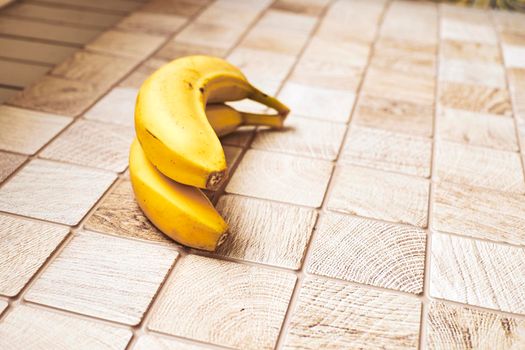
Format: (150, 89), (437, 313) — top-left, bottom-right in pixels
(25, 231), (177, 325)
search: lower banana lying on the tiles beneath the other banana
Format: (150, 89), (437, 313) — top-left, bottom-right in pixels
(129, 139), (228, 251)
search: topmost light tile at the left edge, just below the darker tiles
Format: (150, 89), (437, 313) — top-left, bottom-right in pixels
(0, 105), (71, 154)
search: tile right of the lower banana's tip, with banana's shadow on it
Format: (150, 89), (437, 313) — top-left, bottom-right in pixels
(217, 195), (317, 269)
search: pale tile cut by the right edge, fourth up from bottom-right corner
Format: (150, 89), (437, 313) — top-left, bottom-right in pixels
(435, 141), (525, 193)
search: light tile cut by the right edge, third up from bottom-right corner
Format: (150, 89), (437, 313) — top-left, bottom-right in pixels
(433, 183), (525, 245)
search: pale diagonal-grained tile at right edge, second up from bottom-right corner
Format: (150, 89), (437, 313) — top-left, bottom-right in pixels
(430, 234), (525, 314)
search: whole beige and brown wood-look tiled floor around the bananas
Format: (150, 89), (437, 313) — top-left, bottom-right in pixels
(0, 0), (525, 350)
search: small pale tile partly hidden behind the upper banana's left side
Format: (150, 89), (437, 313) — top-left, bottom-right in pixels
(84, 87), (138, 127)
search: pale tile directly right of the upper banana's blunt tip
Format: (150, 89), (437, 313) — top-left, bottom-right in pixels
(226, 150), (332, 207)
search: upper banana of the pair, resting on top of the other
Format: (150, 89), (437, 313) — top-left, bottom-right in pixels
(135, 56), (289, 190)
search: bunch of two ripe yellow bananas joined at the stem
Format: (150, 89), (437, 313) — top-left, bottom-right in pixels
(129, 56), (289, 251)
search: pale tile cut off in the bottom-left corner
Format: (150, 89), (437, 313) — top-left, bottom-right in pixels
(0, 305), (133, 350)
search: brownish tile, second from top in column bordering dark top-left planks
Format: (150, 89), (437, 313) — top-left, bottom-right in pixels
(116, 11), (187, 37)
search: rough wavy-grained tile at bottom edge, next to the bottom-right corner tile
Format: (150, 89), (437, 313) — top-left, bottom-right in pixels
(283, 278), (421, 350)
